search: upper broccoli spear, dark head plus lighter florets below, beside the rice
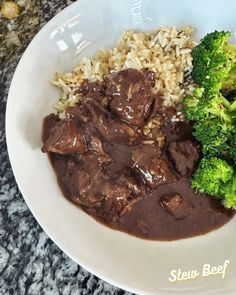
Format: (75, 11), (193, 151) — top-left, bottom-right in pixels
(183, 31), (236, 121)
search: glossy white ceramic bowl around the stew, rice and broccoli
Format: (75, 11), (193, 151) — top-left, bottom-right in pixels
(6, 0), (236, 295)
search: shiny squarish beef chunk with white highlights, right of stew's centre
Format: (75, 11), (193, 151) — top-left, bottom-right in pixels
(132, 145), (176, 189)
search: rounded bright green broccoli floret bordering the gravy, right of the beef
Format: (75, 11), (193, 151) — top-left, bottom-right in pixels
(192, 157), (233, 197)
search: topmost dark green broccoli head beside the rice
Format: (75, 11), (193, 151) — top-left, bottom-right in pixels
(192, 31), (235, 89)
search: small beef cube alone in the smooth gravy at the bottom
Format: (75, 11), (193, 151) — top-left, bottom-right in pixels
(160, 193), (193, 219)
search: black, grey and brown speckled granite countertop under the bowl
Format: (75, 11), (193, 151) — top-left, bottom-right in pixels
(0, 0), (133, 295)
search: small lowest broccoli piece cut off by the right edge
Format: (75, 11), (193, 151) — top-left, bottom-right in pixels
(221, 173), (236, 209)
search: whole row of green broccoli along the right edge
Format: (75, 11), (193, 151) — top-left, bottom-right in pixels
(183, 31), (236, 209)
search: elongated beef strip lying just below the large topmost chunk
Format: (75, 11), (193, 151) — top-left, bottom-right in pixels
(87, 105), (139, 144)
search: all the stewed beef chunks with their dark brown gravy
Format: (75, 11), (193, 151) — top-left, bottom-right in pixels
(42, 70), (234, 240)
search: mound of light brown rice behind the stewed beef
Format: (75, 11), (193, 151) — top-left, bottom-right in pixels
(52, 27), (195, 116)
